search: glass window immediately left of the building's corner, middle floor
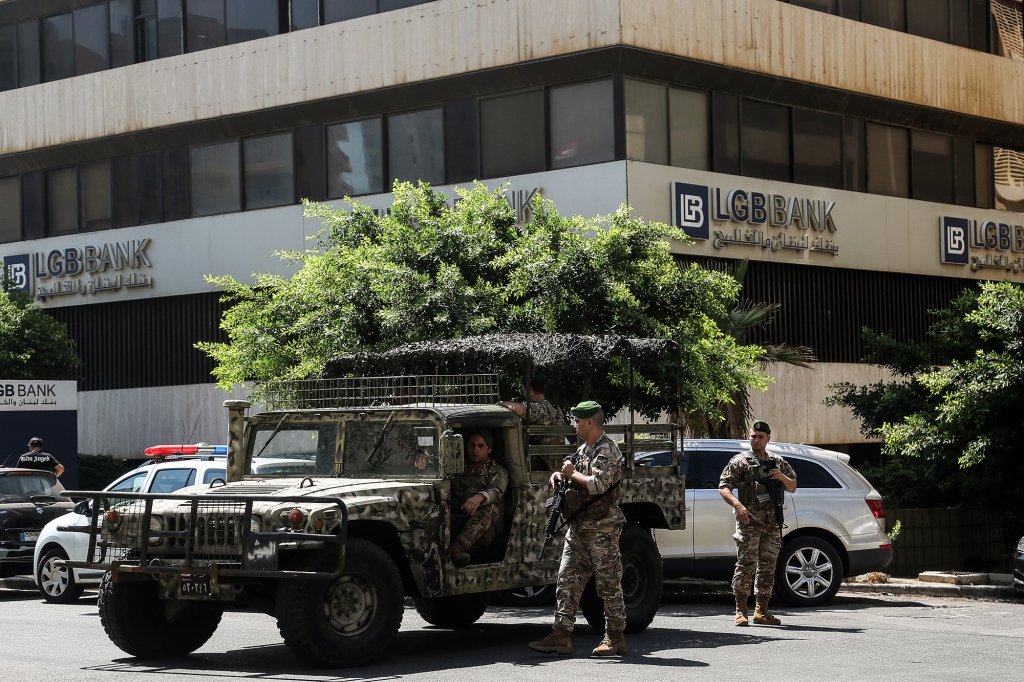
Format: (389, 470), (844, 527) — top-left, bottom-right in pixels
(549, 78), (615, 168)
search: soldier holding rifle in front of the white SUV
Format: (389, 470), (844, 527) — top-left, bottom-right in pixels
(718, 420), (797, 626)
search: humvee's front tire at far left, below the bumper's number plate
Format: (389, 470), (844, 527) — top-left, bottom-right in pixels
(98, 572), (224, 658)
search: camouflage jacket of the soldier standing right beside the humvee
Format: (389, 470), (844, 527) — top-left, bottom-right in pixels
(565, 432), (626, 530)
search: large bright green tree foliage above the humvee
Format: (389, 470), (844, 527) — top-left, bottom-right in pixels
(200, 183), (767, 425)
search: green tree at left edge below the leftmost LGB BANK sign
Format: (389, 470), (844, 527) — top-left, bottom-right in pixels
(0, 287), (79, 380)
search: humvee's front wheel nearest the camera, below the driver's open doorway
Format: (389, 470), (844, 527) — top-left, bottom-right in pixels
(276, 538), (404, 668)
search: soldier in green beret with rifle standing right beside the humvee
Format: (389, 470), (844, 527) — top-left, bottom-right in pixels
(529, 400), (626, 656)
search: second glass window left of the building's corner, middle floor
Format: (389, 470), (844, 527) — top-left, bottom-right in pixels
(480, 90), (546, 177)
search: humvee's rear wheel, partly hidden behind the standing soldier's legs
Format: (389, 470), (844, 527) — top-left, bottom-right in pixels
(580, 525), (662, 635)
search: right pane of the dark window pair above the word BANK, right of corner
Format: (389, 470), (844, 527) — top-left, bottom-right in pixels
(793, 108), (843, 189)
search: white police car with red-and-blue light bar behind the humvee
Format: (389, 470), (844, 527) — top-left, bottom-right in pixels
(33, 443), (227, 603)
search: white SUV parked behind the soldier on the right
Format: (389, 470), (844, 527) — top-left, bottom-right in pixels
(637, 438), (893, 606)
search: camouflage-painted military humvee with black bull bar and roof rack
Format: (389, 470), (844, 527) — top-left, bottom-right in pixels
(68, 366), (685, 667)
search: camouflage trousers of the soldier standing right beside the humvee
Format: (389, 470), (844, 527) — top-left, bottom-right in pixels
(555, 527), (626, 631)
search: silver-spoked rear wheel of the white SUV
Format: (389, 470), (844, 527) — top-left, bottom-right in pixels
(775, 537), (843, 606)
